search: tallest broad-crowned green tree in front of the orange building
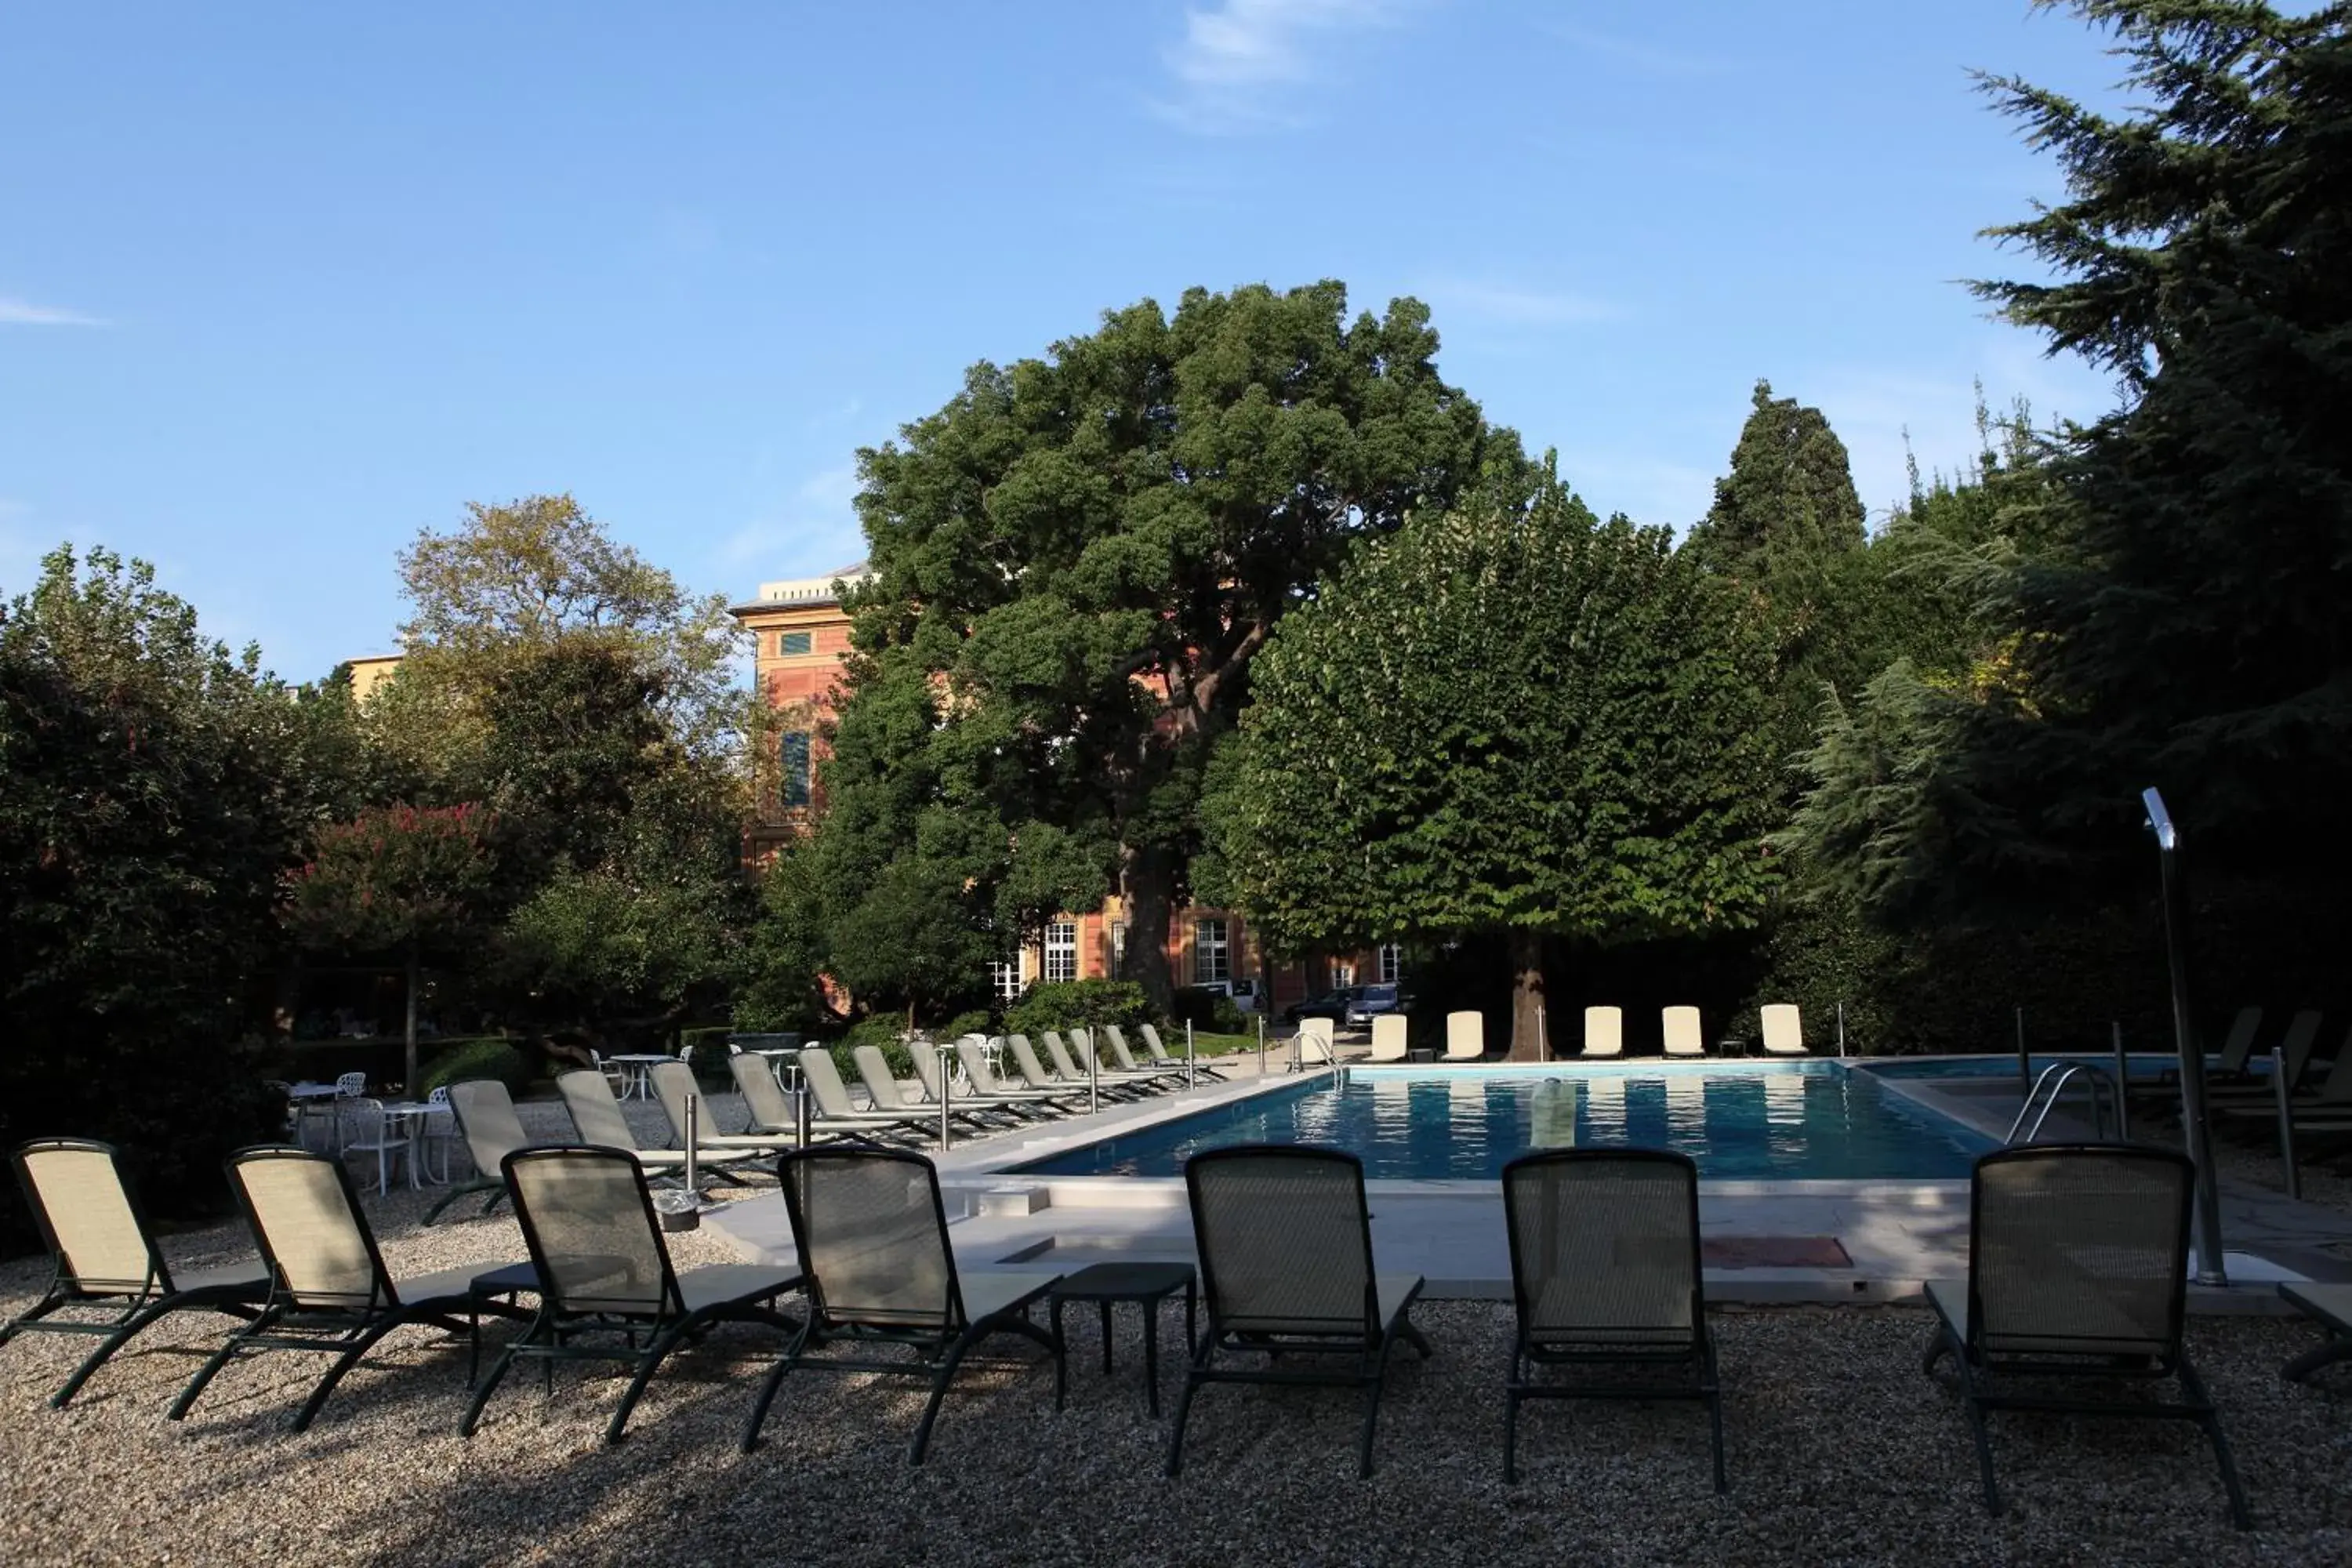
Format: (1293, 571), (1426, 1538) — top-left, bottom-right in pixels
(821, 282), (1529, 1004)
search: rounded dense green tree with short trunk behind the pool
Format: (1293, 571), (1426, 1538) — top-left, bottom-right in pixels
(1209, 487), (1773, 1058)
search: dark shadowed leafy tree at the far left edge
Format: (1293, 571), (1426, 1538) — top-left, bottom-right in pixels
(0, 550), (358, 1236)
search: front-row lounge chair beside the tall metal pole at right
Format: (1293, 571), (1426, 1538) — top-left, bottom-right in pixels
(1922, 1142), (2251, 1530)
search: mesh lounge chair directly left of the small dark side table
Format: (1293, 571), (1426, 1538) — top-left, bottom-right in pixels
(743, 1147), (1070, 1465)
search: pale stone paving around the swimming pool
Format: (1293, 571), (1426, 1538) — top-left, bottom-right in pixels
(710, 1053), (2352, 1314)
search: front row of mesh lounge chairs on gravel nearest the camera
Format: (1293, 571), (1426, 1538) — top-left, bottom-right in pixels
(0, 1140), (2352, 1528)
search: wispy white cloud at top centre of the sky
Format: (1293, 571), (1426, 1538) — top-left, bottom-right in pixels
(1152, 0), (1423, 136)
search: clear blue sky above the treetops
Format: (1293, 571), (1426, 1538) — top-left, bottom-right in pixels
(0, 0), (2114, 680)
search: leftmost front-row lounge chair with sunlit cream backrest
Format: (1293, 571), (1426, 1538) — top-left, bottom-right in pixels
(0, 1138), (270, 1410)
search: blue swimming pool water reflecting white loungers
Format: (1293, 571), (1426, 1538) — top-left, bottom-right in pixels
(1018, 1062), (1992, 1180)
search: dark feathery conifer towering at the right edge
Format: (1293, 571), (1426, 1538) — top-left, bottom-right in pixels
(1809, 0), (2352, 905)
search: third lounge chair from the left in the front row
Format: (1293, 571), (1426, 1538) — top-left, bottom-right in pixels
(459, 1149), (800, 1443)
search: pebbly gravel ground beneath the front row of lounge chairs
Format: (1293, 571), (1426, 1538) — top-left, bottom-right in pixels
(0, 1171), (2352, 1566)
